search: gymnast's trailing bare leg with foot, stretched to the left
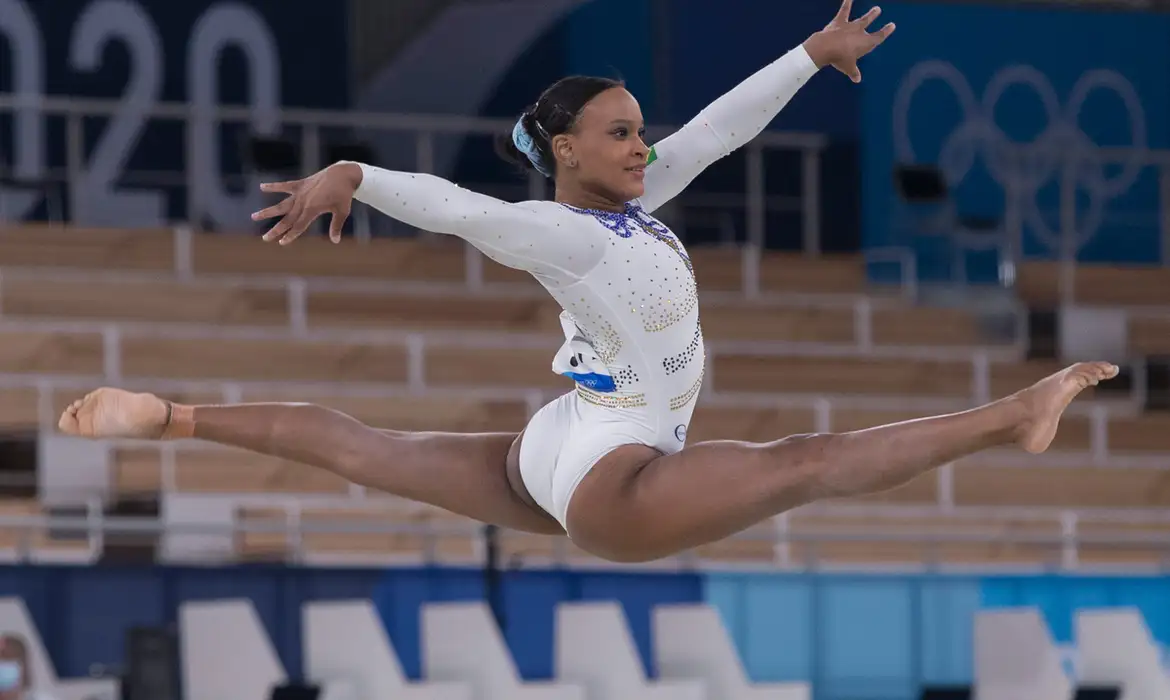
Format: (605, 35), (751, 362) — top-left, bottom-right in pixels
(60, 389), (564, 534)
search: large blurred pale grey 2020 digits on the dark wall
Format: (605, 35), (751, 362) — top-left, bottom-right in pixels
(0, 0), (281, 227)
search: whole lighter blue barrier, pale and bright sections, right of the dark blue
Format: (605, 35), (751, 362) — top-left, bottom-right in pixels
(704, 574), (1170, 700)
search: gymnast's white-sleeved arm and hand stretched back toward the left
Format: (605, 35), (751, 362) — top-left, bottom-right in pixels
(253, 162), (605, 284)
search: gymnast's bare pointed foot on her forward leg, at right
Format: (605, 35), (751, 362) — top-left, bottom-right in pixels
(1016, 362), (1117, 454)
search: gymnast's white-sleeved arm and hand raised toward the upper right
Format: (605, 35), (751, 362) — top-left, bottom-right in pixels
(639, 0), (894, 212)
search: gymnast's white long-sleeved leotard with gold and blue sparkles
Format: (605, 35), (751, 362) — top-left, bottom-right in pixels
(355, 47), (817, 523)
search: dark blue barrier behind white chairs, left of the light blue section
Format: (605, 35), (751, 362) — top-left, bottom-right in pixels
(0, 567), (702, 679)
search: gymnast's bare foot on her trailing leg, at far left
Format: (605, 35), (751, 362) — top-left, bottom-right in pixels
(57, 387), (166, 440)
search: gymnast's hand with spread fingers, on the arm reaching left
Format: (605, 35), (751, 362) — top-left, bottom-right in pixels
(252, 163), (362, 246)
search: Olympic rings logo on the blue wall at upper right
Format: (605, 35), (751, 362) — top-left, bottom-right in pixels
(893, 60), (1148, 248)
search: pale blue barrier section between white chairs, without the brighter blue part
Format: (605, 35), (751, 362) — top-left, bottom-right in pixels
(707, 574), (980, 700)
